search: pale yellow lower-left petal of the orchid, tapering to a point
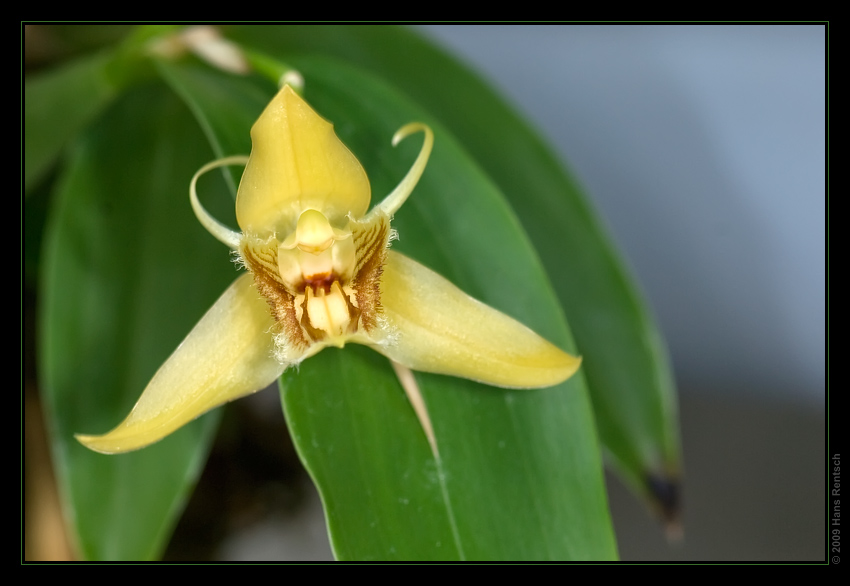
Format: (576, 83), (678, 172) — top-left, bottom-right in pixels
(76, 273), (283, 454)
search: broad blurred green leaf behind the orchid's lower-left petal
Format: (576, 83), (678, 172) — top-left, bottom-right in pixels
(40, 82), (236, 560)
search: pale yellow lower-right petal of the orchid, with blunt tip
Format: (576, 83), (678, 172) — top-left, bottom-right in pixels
(374, 251), (581, 388)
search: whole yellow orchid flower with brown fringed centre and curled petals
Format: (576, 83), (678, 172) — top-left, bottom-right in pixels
(77, 85), (581, 454)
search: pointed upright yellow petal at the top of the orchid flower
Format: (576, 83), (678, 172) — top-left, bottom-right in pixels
(236, 85), (371, 235)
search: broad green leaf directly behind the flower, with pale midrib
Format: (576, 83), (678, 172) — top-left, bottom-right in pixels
(156, 61), (616, 560)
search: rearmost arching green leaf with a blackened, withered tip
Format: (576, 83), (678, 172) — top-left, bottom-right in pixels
(226, 26), (680, 516)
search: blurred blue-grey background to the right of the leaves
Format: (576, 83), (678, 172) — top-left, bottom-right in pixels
(408, 25), (826, 560)
